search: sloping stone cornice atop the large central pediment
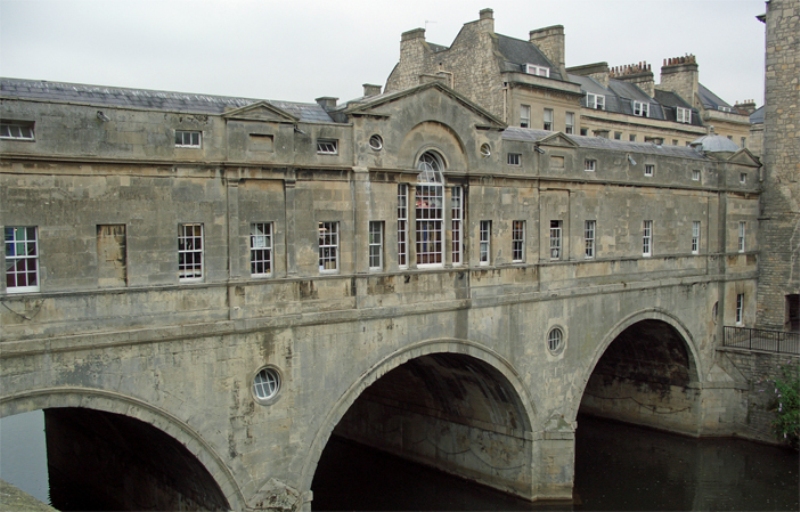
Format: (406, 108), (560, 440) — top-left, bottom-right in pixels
(344, 82), (508, 130)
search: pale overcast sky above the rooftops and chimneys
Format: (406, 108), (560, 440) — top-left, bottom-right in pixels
(0, 0), (765, 106)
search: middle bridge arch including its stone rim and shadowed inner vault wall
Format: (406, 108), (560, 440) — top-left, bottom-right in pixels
(301, 339), (536, 498)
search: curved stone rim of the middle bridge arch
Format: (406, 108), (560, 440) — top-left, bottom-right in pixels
(300, 339), (537, 502)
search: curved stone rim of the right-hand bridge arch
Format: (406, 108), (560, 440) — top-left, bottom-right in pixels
(569, 308), (703, 421)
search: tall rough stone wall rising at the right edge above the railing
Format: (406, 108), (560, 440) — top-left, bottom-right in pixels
(758, 0), (800, 330)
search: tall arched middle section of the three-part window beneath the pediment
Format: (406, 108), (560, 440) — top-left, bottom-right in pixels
(415, 151), (444, 266)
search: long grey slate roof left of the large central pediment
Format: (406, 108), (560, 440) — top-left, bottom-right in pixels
(0, 78), (333, 123)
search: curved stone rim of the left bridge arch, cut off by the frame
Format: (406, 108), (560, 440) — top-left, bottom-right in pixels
(0, 386), (246, 510)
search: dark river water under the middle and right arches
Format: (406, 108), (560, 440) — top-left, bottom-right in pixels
(312, 417), (800, 511)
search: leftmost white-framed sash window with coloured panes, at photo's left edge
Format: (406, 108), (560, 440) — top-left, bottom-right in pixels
(3, 226), (39, 293)
